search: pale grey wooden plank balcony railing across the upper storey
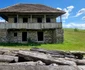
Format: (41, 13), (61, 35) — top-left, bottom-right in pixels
(0, 23), (62, 29)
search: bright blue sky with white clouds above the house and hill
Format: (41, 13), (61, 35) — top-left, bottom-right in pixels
(0, 0), (85, 29)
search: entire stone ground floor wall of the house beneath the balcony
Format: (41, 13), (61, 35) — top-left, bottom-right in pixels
(0, 29), (63, 43)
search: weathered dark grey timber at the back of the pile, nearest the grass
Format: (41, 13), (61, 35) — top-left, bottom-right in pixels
(30, 48), (75, 58)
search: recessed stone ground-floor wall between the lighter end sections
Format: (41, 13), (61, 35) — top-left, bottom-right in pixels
(8, 30), (54, 43)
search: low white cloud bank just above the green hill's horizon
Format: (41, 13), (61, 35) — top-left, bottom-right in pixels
(63, 23), (85, 29)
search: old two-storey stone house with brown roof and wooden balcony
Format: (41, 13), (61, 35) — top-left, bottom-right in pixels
(0, 4), (65, 43)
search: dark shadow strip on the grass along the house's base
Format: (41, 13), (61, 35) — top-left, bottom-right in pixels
(0, 43), (41, 47)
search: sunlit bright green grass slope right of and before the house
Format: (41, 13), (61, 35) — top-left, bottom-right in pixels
(39, 29), (85, 51)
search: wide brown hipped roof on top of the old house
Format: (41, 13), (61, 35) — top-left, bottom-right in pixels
(0, 4), (65, 14)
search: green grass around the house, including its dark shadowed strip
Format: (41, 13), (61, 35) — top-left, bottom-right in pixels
(0, 29), (85, 51)
